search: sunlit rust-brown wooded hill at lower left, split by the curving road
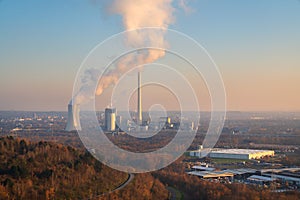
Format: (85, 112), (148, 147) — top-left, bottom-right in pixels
(0, 136), (168, 199)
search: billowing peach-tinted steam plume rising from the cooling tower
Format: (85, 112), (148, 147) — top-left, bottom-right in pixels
(73, 0), (186, 104)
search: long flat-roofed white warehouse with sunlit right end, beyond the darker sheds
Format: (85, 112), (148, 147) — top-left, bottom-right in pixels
(209, 149), (275, 160)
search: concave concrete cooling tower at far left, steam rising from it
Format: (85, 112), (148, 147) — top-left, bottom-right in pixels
(66, 101), (81, 131)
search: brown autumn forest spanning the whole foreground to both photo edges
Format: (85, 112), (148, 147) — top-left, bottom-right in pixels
(0, 136), (300, 200)
